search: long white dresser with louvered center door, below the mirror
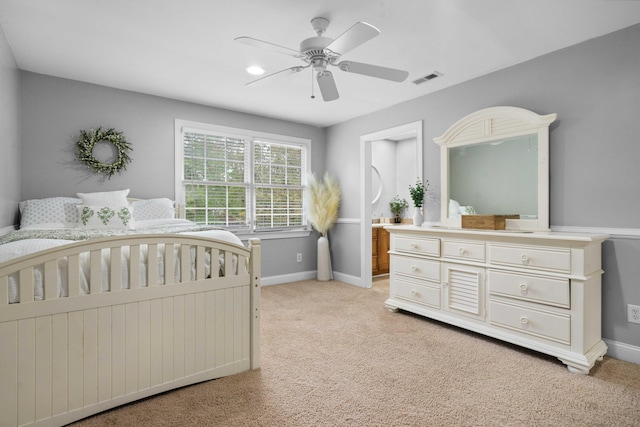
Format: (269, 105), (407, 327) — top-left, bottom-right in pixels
(385, 226), (608, 374)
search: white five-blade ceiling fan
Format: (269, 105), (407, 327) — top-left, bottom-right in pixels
(235, 18), (409, 101)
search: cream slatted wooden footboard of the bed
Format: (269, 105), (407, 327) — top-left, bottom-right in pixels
(0, 234), (260, 426)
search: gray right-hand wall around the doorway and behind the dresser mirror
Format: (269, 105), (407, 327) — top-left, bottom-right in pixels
(327, 25), (640, 346)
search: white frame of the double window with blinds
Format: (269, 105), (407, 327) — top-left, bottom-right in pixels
(174, 119), (311, 239)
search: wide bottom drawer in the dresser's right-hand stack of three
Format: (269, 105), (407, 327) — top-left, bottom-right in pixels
(489, 301), (571, 344)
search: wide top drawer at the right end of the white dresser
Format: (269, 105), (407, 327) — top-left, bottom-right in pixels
(489, 243), (571, 273)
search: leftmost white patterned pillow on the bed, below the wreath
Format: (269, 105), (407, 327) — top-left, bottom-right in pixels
(18, 197), (82, 228)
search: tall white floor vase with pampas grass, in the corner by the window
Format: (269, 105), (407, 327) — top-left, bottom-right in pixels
(307, 173), (340, 281)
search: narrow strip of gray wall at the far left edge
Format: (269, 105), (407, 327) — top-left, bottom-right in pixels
(0, 27), (20, 228)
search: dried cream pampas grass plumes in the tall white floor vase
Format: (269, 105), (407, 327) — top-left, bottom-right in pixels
(307, 173), (340, 236)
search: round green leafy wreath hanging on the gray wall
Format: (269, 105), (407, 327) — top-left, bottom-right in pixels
(76, 127), (132, 179)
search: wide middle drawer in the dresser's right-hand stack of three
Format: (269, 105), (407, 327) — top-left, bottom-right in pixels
(487, 270), (571, 308)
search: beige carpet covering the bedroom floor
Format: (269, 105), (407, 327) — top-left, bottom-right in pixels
(71, 281), (640, 427)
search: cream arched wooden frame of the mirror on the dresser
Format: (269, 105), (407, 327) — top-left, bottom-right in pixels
(433, 107), (558, 231)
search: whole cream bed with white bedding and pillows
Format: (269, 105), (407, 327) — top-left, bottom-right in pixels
(0, 190), (260, 426)
